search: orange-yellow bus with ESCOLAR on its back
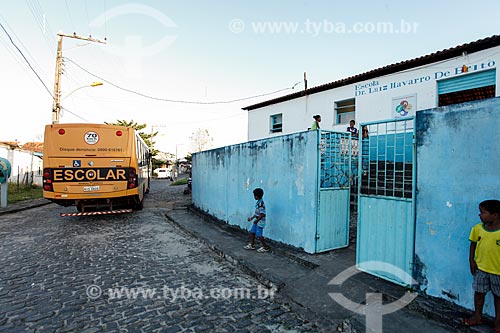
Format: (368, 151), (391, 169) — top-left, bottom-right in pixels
(43, 124), (151, 215)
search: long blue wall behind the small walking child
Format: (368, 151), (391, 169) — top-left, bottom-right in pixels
(192, 131), (319, 253)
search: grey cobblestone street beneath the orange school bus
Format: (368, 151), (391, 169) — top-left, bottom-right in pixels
(0, 181), (318, 333)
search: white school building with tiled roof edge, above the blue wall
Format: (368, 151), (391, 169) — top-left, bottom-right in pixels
(243, 35), (500, 141)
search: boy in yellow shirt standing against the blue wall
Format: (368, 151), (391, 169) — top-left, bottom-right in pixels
(464, 200), (500, 333)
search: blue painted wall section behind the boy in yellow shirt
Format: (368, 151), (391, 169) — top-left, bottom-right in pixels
(415, 98), (500, 315)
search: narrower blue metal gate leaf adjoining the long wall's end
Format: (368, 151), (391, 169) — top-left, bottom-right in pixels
(316, 131), (353, 253)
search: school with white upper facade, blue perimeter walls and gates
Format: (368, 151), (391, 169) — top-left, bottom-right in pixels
(192, 36), (500, 315)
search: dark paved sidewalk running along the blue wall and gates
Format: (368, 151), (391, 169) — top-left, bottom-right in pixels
(167, 206), (484, 333)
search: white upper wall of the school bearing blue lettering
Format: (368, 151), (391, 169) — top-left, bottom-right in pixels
(248, 46), (500, 141)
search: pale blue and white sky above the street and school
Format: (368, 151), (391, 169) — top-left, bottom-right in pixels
(0, 0), (500, 157)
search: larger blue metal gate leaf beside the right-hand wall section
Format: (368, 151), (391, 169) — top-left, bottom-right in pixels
(356, 117), (416, 285)
